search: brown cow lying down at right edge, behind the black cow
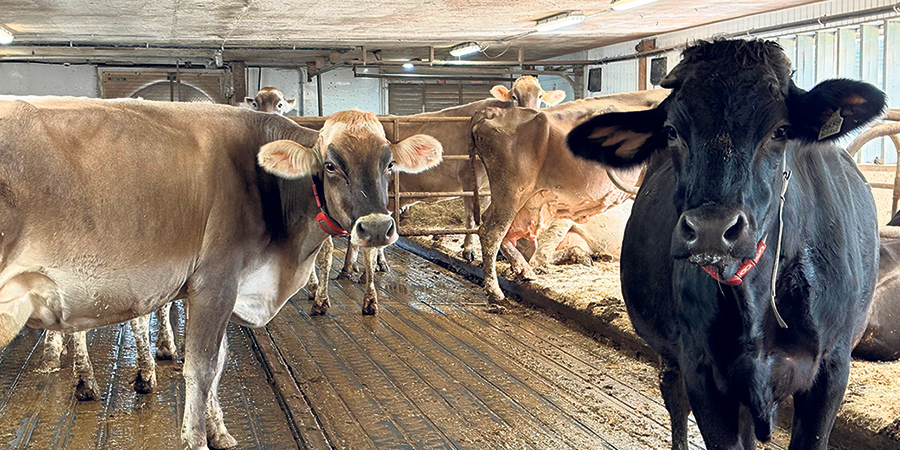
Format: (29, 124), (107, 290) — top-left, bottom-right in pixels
(853, 213), (900, 361)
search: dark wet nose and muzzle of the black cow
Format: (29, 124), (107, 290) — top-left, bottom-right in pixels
(672, 205), (752, 265)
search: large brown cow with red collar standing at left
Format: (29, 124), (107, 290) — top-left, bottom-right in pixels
(0, 98), (441, 449)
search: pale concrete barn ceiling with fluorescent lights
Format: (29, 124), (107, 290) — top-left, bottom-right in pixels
(0, 0), (828, 64)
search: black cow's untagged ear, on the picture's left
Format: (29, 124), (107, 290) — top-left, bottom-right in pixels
(567, 105), (667, 167)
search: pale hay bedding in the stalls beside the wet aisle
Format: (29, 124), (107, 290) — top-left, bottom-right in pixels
(403, 195), (900, 441)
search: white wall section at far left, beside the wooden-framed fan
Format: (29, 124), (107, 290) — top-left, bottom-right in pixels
(0, 63), (100, 97)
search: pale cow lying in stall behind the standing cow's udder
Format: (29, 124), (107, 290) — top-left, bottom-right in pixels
(516, 200), (634, 269)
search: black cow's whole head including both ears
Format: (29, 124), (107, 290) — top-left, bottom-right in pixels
(568, 40), (885, 278)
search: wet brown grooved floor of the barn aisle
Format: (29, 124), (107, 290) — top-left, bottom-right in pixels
(0, 241), (808, 450)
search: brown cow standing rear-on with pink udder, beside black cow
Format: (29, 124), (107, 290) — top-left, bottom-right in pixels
(472, 90), (668, 305)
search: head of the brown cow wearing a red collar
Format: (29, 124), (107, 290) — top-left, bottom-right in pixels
(258, 110), (443, 247)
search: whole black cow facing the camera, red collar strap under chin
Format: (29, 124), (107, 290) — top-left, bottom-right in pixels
(568, 40), (885, 450)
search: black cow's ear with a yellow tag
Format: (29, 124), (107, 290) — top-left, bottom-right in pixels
(788, 79), (885, 141)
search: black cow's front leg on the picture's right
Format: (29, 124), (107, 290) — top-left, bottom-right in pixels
(788, 351), (850, 450)
